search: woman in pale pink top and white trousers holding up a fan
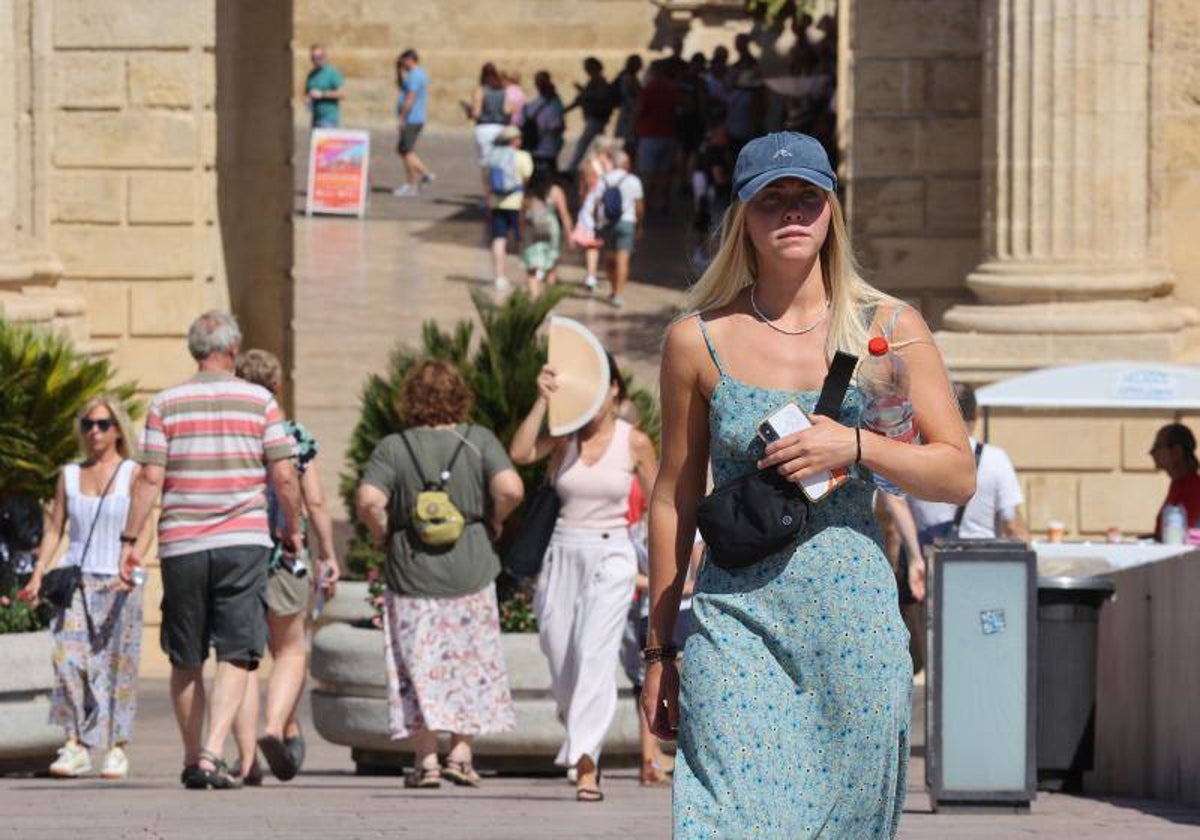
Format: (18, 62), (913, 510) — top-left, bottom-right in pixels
(509, 356), (658, 802)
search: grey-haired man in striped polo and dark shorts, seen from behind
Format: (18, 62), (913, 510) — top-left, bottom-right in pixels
(121, 312), (302, 790)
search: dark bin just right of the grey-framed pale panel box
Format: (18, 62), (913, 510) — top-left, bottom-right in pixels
(1037, 577), (1115, 793)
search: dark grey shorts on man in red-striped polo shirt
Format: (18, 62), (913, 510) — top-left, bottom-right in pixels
(160, 546), (271, 670)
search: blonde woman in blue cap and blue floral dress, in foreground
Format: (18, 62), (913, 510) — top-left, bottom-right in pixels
(642, 132), (974, 840)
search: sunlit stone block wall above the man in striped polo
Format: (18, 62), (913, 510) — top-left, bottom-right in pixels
(43, 0), (228, 391)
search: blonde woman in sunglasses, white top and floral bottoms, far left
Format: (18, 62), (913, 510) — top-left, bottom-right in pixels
(20, 394), (149, 779)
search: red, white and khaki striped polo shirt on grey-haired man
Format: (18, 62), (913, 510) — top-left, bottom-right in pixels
(142, 371), (292, 557)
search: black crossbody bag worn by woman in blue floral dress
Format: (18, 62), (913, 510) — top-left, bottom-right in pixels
(696, 350), (858, 569)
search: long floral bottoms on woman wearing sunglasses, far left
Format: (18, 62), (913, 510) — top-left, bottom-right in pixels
(50, 574), (142, 749)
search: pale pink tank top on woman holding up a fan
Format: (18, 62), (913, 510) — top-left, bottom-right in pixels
(554, 420), (634, 530)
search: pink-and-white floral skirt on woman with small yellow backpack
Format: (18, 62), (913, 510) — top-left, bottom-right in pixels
(384, 584), (516, 740)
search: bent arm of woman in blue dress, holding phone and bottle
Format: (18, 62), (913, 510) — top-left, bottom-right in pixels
(758, 307), (976, 504)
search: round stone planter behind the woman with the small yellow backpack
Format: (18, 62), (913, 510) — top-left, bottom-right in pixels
(311, 600), (641, 773)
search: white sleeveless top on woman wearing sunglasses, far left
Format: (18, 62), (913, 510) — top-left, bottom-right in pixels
(62, 461), (136, 575)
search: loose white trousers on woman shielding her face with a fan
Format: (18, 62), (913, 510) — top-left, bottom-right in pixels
(534, 528), (637, 767)
